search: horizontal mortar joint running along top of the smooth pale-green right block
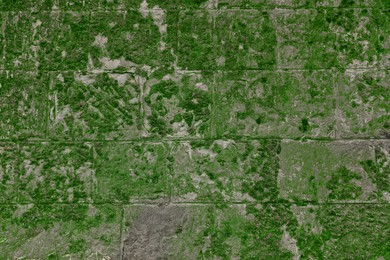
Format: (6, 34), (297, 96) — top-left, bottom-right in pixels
(0, 137), (390, 144)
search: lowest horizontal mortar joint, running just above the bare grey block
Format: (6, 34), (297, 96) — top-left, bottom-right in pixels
(0, 201), (390, 207)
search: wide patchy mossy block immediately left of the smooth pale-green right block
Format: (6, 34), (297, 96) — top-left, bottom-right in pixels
(171, 140), (280, 203)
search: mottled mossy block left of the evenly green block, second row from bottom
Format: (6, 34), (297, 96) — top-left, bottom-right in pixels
(18, 143), (96, 204)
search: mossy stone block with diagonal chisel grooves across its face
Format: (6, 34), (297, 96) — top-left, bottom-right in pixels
(49, 72), (142, 140)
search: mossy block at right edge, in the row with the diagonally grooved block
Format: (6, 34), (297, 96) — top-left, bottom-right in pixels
(337, 69), (390, 138)
